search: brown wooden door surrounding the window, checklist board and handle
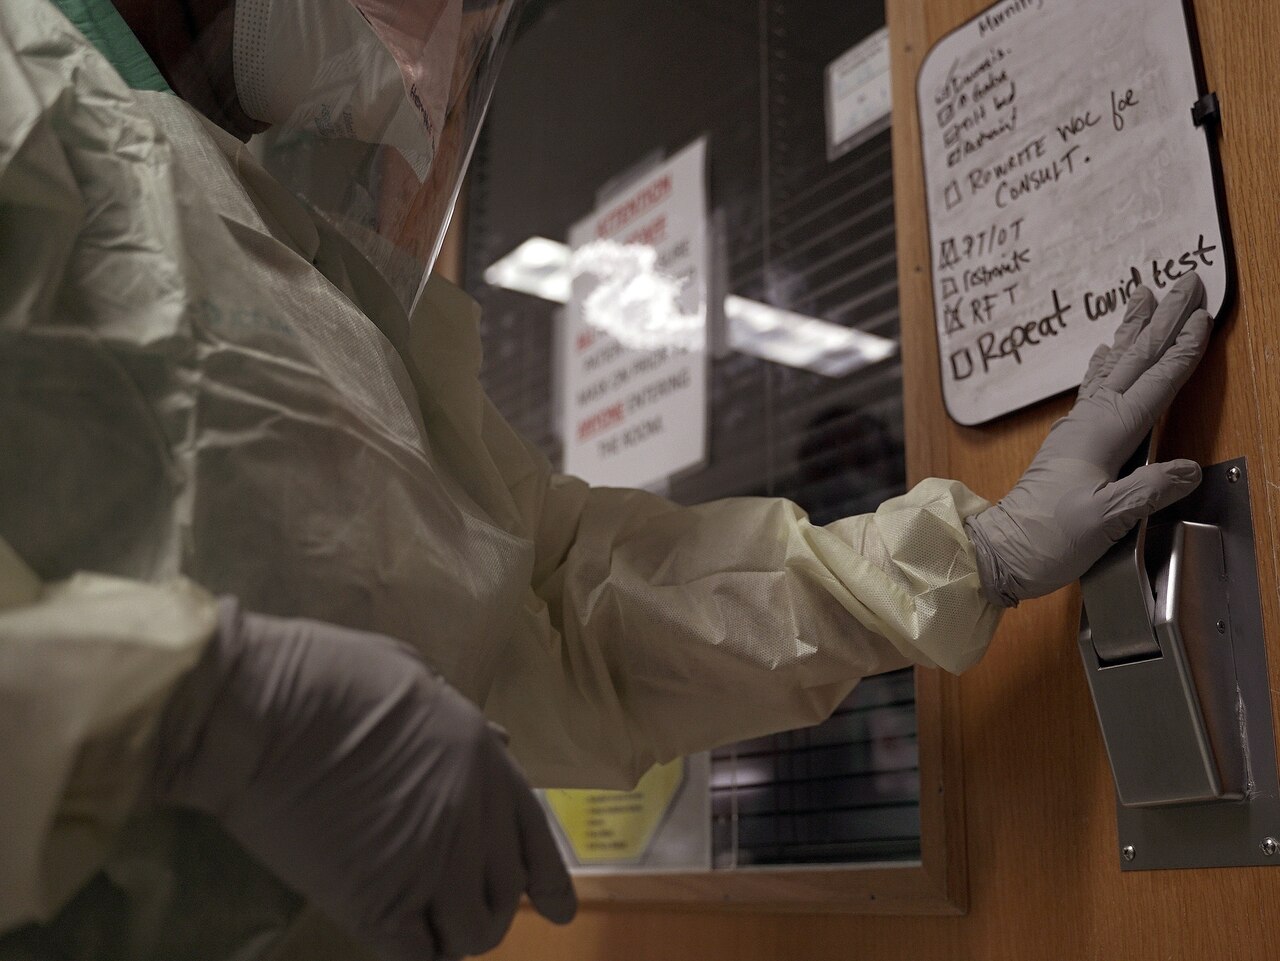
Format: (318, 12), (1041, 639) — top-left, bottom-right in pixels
(483, 0), (1280, 961)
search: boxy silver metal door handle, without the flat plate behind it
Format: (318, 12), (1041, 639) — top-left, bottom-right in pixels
(1080, 506), (1245, 806)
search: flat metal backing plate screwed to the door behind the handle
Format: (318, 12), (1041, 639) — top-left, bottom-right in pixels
(1080, 458), (1280, 871)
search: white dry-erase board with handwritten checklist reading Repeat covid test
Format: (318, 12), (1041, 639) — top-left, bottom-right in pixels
(916, 0), (1230, 425)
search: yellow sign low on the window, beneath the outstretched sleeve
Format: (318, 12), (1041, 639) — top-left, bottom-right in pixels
(547, 759), (685, 865)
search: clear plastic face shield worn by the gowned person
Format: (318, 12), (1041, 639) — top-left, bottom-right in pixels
(232, 0), (524, 308)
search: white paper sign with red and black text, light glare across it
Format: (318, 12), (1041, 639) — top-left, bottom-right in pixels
(561, 139), (708, 488)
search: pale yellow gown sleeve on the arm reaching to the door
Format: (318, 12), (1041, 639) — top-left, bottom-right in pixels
(416, 283), (1001, 787)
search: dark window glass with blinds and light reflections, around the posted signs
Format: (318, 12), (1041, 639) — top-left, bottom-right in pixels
(465, 0), (919, 868)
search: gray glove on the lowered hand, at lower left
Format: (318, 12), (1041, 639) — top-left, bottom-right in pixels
(156, 600), (577, 961)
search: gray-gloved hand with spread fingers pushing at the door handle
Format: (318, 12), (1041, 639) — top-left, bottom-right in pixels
(965, 274), (1212, 607)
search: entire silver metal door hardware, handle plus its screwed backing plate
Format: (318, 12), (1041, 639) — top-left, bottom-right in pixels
(1079, 458), (1280, 870)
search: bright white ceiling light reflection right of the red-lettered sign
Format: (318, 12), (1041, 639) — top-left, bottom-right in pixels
(724, 294), (897, 377)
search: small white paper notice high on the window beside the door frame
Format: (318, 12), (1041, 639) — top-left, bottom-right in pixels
(826, 27), (891, 160)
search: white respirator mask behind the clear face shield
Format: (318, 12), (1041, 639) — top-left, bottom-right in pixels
(232, 0), (462, 180)
